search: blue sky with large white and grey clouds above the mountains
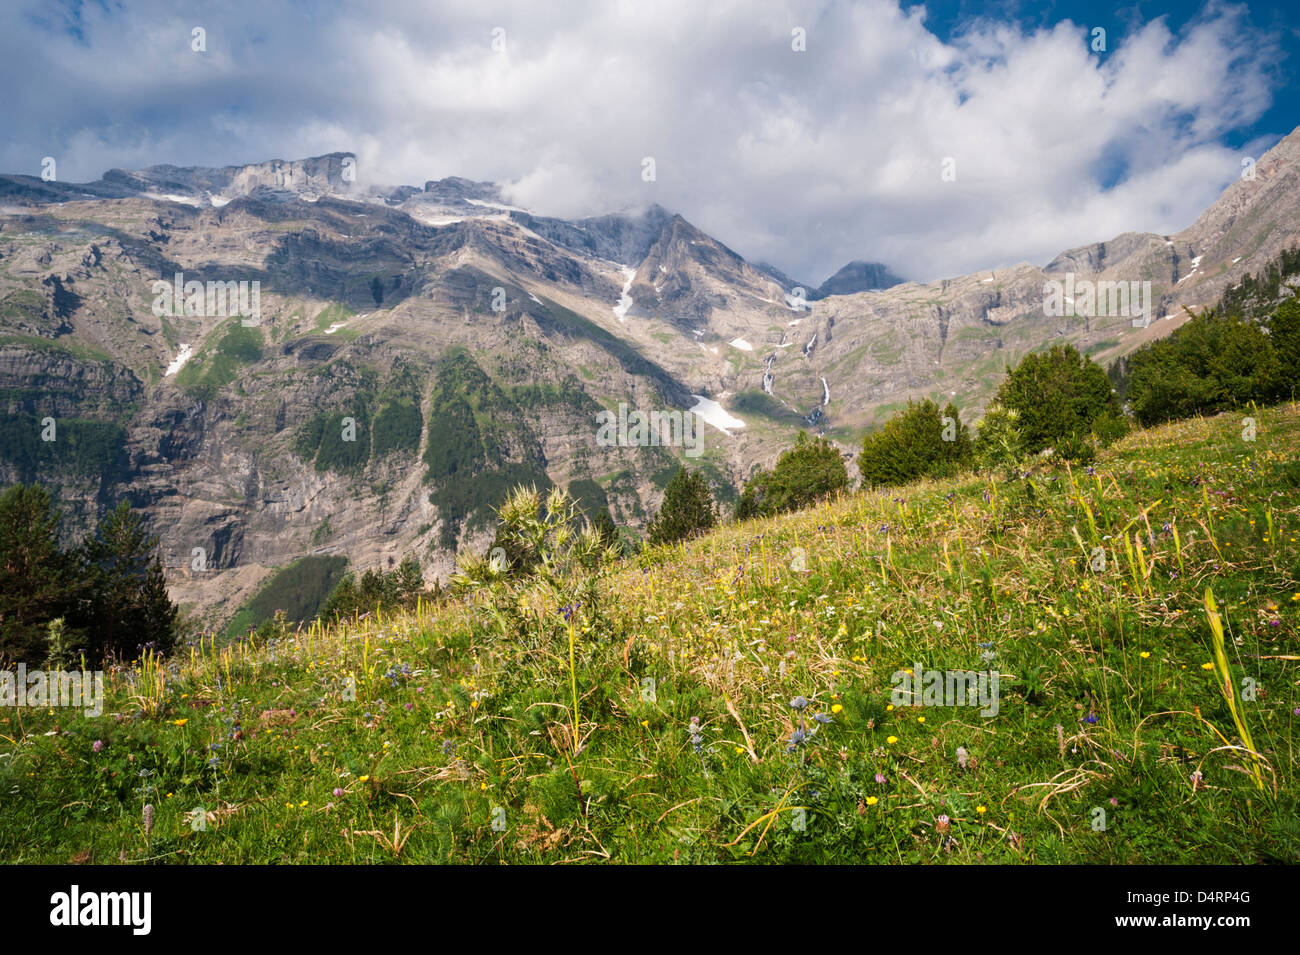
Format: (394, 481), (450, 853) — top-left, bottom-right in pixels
(0, 0), (1300, 283)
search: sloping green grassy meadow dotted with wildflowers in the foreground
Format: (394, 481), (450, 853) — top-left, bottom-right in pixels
(0, 405), (1300, 864)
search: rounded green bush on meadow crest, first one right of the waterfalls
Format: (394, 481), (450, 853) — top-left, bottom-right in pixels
(858, 398), (971, 487)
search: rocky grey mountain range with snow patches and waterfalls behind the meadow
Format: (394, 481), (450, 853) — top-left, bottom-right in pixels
(0, 127), (1300, 631)
